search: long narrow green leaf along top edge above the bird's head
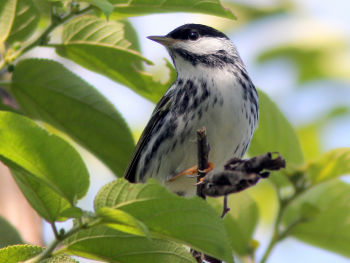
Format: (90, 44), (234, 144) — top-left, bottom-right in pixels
(110, 0), (236, 19)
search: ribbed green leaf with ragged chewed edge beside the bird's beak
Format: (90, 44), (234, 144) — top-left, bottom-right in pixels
(55, 15), (172, 102)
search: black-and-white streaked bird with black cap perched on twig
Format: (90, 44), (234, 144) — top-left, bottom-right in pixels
(124, 24), (259, 197)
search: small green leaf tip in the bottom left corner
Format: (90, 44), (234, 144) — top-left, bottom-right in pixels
(0, 245), (44, 263)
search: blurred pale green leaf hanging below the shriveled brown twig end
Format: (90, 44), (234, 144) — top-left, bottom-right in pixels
(207, 191), (259, 255)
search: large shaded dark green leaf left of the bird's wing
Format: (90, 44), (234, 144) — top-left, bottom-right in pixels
(12, 59), (134, 176)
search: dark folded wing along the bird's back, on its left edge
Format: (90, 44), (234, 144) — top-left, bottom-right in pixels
(124, 89), (173, 183)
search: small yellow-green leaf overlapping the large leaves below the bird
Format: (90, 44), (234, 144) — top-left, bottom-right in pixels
(97, 207), (149, 237)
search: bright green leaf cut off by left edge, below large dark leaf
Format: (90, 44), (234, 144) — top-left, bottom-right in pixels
(0, 112), (89, 222)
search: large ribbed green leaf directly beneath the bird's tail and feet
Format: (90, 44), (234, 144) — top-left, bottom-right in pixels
(95, 179), (232, 262)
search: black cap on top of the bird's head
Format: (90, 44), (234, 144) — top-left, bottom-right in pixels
(166, 24), (228, 40)
